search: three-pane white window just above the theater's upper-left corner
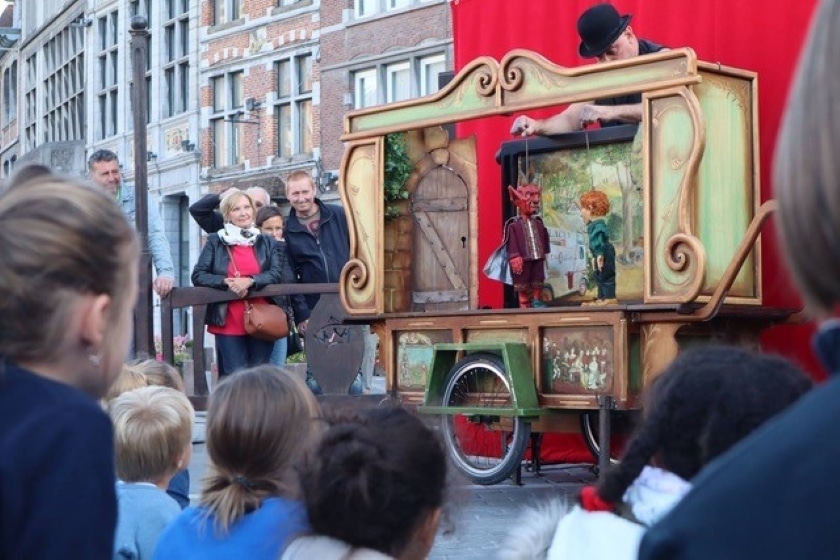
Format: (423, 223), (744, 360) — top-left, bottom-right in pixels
(352, 53), (446, 109)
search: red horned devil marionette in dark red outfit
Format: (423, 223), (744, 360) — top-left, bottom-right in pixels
(506, 184), (550, 307)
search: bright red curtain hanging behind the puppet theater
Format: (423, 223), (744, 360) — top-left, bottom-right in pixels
(450, 0), (822, 376)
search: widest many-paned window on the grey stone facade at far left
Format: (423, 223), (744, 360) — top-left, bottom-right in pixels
(42, 27), (85, 142)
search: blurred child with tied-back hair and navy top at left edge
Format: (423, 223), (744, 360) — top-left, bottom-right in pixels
(0, 172), (139, 558)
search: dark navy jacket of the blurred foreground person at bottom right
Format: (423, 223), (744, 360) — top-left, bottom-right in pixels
(638, 320), (840, 560)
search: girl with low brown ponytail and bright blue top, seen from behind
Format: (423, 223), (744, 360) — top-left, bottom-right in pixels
(155, 366), (321, 560)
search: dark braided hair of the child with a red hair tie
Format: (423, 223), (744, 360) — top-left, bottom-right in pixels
(596, 346), (813, 504)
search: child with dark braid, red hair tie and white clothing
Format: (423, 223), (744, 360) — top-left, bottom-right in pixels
(499, 346), (812, 560)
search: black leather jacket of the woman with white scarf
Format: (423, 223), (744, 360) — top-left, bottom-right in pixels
(192, 233), (303, 326)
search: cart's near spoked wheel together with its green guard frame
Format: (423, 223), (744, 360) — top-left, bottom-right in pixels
(418, 343), (542, 484)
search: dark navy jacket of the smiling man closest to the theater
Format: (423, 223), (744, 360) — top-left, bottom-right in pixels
(283, 199), (350, 322)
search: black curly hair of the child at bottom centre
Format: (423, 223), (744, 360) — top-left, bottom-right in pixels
(300, 407), (446, 557)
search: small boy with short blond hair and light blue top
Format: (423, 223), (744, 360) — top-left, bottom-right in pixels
(109, 387), (194, 560)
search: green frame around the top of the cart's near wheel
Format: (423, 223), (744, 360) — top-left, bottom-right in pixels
(417, 342), (547, 418)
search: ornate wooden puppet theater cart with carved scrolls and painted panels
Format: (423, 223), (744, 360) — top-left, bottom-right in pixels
(339, 49), (788, 483)
